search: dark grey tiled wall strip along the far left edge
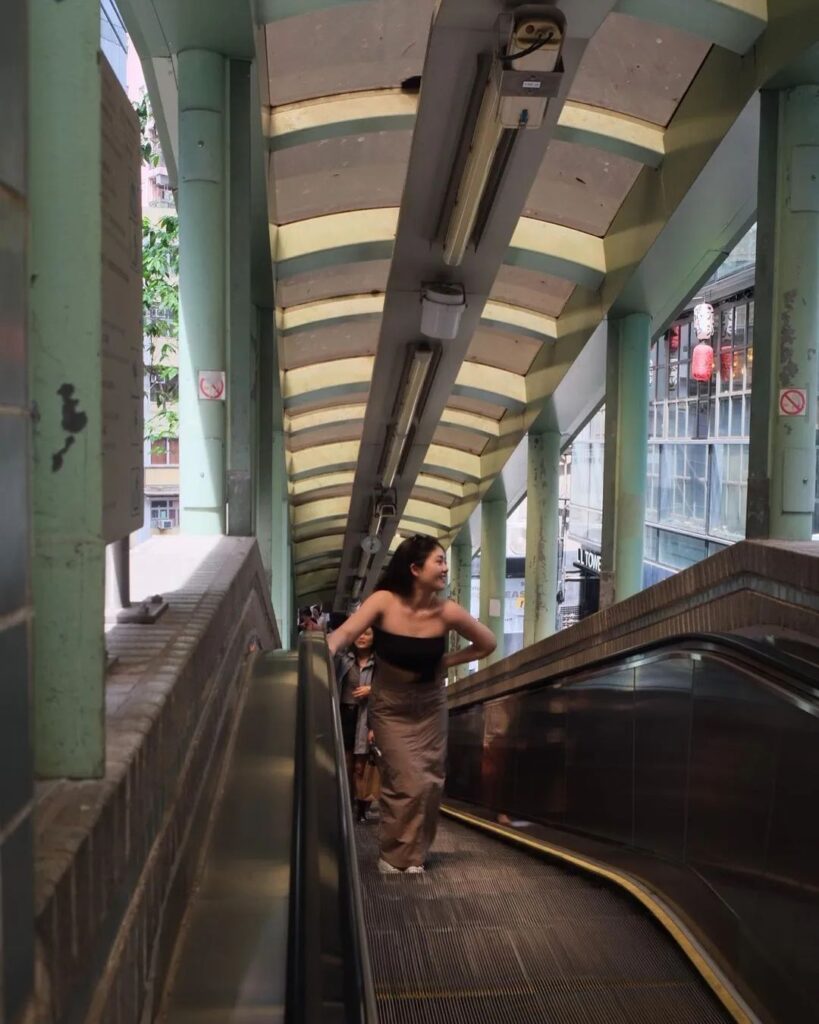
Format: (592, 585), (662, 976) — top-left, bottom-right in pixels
(0, 0), (34, 1024)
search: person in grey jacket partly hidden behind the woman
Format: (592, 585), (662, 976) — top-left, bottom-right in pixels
(331, 629), (377, 821)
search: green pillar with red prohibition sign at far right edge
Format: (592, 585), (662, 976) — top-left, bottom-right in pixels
(746, 85), (819, 541)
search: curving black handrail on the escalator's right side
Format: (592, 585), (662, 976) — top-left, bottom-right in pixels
(452, 633), (819, 710)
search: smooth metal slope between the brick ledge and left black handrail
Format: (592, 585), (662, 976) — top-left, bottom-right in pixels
(158, 651), (296, 1024)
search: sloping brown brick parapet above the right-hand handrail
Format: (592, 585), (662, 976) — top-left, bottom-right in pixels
(448, 541), (819, 708)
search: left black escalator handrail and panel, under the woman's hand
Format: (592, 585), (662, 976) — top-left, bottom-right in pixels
(286, 633), (378, 1024)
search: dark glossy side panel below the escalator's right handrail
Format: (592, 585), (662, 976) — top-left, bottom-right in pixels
(447, 637), (819, 1020)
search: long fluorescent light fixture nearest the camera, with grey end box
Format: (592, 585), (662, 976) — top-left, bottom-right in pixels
(443, 4), (566, 266)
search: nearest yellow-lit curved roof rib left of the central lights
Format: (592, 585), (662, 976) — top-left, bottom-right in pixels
(262, 89), (418, 153)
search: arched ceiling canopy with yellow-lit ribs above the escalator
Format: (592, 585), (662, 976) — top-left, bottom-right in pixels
(250, 0), (818, 604)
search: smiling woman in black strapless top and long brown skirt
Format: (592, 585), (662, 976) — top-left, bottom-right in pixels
(328, 534), (495, 873)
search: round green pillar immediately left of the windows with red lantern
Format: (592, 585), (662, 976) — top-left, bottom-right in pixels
(600, 313), (651, 607)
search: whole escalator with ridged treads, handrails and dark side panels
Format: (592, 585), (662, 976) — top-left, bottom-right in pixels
(159, 634), (819, 1024)
